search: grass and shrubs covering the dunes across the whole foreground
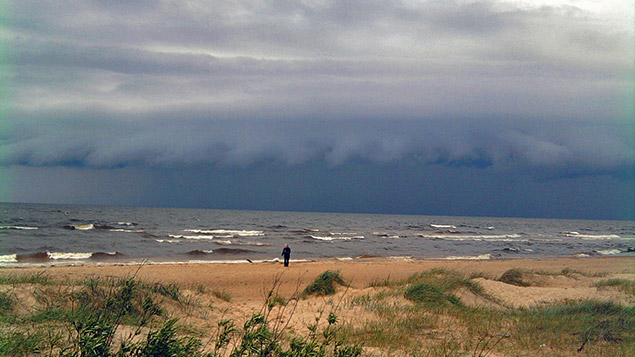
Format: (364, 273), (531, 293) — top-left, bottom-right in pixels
(0, 262), (635, 356)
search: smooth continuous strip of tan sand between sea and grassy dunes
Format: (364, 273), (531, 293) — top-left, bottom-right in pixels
(0, 257), (635, 306)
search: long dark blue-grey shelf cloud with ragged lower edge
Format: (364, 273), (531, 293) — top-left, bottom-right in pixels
(0, 110), (635, 176)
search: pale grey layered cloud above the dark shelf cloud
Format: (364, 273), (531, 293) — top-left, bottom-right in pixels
(0, 1), (633, 121)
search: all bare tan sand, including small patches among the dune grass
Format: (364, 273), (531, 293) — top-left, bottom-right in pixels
(0, 257), (635, 355)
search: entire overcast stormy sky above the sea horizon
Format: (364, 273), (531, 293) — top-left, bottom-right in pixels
(0, 0), (635, 220)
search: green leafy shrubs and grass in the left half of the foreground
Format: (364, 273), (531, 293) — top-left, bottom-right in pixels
(0, 277), (361, 357)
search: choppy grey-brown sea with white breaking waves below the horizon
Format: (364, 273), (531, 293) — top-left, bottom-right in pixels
(0, 203), (635, 266)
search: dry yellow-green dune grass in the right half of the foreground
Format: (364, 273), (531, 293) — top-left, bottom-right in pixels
(346, 269), (635, 356)
